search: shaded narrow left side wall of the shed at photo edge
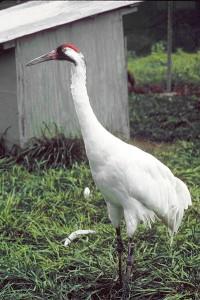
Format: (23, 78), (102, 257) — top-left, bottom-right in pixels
(0, 48), (19, 146)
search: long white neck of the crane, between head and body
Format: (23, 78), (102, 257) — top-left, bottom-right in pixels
(71, 57), (107, 152)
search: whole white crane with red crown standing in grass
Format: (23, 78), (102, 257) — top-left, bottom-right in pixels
(28, 44), (191, 294)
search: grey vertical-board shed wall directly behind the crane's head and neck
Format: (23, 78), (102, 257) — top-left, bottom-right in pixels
(16, 11), (129, 144)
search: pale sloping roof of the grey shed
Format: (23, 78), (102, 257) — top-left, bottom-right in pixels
(0, 1), (139, 43)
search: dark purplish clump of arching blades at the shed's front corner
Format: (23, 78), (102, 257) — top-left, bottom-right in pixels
(15, 134), (87, 170)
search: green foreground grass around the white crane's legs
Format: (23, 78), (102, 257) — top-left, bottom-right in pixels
(0, 142), (200, 300)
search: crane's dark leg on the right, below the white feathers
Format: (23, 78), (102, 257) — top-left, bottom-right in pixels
(122, 239), (134, 300)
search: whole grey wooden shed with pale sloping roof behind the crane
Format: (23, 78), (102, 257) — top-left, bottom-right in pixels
(0, 1), (138, 146)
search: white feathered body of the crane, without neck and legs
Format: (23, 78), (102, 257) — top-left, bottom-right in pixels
(91, 139), (191, 236)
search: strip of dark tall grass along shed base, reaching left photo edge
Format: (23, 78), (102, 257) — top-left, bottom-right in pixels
(0, 125), (87, 171)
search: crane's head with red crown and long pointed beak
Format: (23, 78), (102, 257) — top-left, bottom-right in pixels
(26, 44), (82, 66)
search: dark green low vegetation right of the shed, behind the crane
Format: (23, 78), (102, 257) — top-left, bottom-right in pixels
(129, 94), (200, 142)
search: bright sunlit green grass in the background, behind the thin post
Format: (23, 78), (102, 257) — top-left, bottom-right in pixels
(128, 43), (200, 86)
